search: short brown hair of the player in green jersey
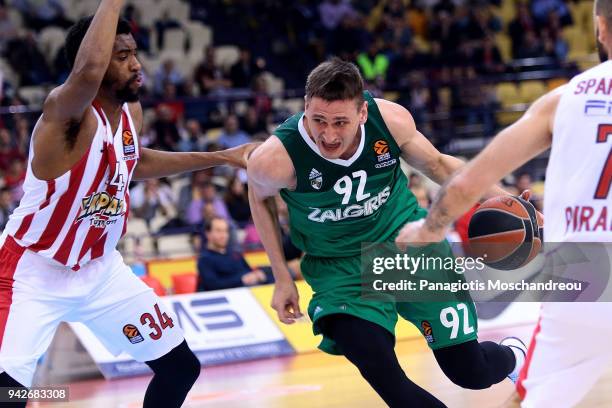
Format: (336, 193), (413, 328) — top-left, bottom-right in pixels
(306, 57), (363, 106)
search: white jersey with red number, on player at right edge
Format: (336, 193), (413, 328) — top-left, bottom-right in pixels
(544, 61), (612, 242)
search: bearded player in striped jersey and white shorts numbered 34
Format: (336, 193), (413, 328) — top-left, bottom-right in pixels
(0, 0), (253, 408)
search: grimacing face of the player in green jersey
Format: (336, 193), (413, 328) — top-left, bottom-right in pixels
(304, 97), (368, 160)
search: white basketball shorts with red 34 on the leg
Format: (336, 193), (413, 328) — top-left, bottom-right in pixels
(0, 237), (183, 387)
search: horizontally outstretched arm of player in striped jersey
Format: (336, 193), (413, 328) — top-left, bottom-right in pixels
(134, 143), (261, 180)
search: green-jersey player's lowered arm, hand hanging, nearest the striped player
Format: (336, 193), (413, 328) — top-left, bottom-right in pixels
(247, 136), (301, 324)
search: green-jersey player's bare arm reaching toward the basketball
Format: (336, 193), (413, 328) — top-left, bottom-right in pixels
(376, 99), (508, 197)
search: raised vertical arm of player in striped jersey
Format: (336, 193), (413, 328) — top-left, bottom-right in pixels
(43, 0), (125, 124)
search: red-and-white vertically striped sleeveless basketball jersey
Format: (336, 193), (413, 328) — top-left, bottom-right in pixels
(2, 103), (139, 270)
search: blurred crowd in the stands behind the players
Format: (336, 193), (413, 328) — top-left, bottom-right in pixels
(0, 0), (597, 282)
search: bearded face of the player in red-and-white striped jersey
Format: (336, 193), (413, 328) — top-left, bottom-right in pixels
(102, 34), (142, 102)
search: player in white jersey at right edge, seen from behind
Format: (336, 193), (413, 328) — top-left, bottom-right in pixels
(396, 0), (612, 408)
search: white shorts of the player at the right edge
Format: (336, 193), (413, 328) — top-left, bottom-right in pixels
(517, 302), (612, 408)
